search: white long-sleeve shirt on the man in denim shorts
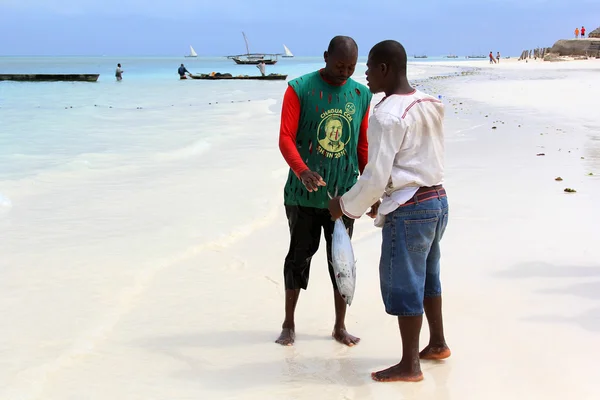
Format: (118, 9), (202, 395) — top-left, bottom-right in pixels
(341, 90), (444, 227)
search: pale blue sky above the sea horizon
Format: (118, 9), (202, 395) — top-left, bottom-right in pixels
(0, 0), (600, 56)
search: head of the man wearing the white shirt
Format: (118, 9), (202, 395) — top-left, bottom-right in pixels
(366, 40), (408, 93)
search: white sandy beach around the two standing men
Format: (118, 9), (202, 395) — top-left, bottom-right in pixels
(0, 60), (600, 400)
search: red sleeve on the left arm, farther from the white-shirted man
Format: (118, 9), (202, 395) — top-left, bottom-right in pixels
(279, 86), (308, 176)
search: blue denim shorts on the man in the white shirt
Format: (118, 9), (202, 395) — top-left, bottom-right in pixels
(379, 191), (448, 316)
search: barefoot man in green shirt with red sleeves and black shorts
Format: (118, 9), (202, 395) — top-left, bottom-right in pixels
(276, 36), (375, 346)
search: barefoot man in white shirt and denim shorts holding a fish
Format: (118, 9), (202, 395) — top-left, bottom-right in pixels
(329, 40), (450, 382)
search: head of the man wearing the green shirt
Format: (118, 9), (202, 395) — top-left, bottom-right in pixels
(323, 36), (358, 84)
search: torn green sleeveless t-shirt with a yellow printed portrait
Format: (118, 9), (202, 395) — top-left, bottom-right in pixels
(284, 71), (373, 208)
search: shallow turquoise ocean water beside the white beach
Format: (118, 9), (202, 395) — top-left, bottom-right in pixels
(0, 57), (462, 184)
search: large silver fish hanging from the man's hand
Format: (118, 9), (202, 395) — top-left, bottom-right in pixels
(331, 218), (356, 305)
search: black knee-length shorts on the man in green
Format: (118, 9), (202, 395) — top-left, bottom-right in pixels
(283, 206), (354, 290)
